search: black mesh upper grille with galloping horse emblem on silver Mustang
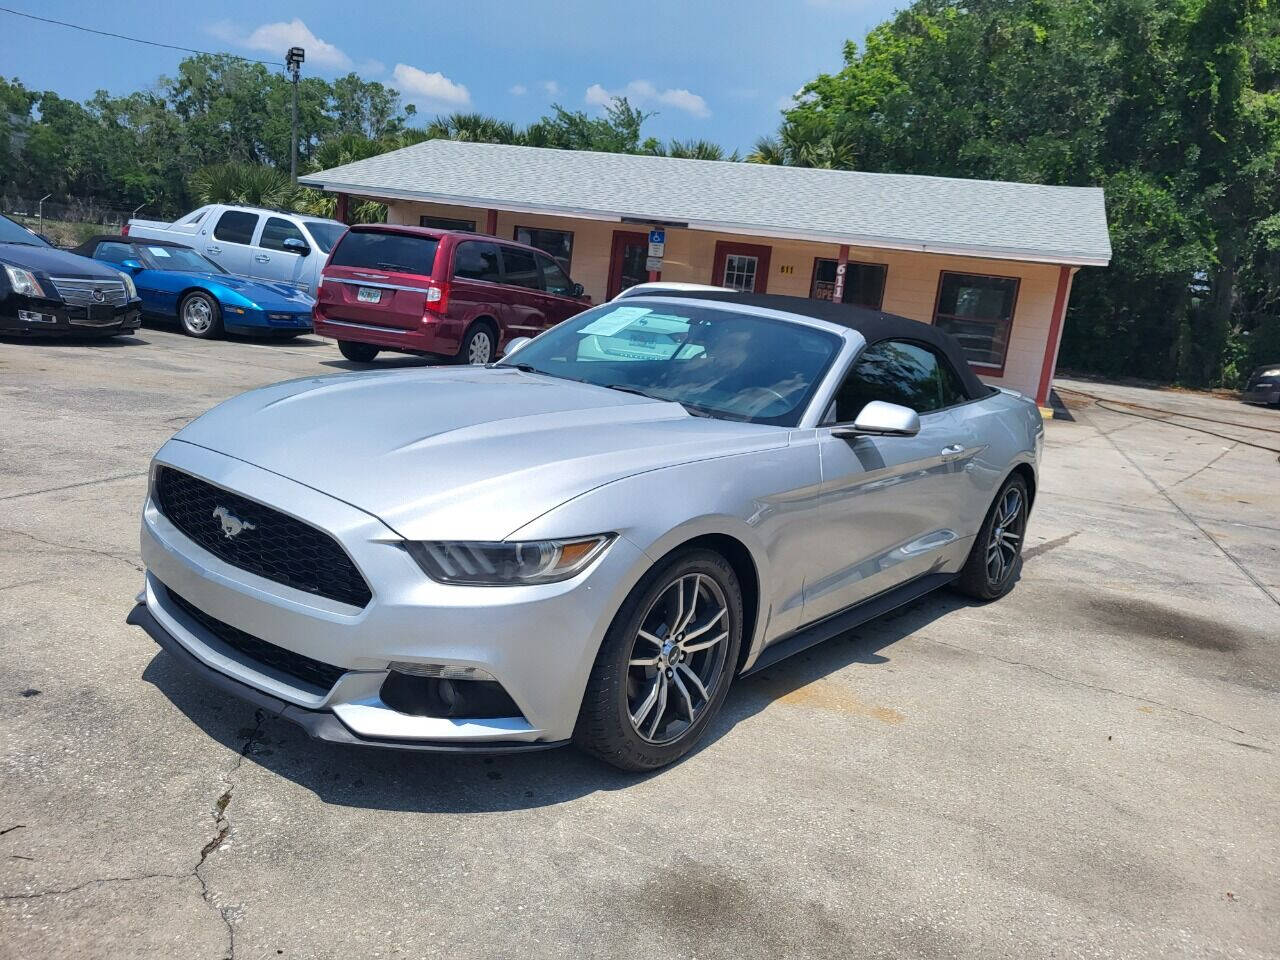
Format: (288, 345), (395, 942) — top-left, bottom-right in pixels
(155, 467), (372, 607)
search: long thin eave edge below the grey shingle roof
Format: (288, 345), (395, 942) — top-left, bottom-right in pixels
(298, 177), (1111, 266)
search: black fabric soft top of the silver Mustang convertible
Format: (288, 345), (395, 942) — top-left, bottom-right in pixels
(646, 291), (992, 399)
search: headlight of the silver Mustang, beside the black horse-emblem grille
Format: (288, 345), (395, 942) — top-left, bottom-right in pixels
(404, 534), (613, 586)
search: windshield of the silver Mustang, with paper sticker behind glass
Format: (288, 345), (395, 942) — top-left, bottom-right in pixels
(499, 298), (841, 426)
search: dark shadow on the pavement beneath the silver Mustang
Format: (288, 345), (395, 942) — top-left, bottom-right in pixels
(142, 590), (998, 813)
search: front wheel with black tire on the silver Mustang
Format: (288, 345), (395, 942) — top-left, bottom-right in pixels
(573, 549), (742, 771)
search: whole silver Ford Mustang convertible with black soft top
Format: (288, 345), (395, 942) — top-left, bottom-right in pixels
(129, 292), (1043, 769)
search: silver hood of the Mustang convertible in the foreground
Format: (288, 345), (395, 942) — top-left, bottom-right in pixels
(177, 367), (788, 540)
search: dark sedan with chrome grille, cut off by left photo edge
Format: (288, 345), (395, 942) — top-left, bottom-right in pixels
(0, 216), (142, 337)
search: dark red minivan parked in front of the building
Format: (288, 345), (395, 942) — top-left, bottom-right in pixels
(312, 224), (590, 364)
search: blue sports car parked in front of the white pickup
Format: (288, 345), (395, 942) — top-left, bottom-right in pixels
(76, 237), (315, 338)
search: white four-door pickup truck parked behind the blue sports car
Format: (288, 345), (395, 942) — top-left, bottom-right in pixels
(123, 204), (347, 297)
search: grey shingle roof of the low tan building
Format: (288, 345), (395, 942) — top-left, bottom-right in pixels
(298, 140), (1111, 265)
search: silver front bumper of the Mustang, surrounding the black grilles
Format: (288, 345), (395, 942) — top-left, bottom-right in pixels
(131, 440), (645, 750)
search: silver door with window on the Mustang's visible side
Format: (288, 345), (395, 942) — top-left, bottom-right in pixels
(805, 340), (973, 621)
